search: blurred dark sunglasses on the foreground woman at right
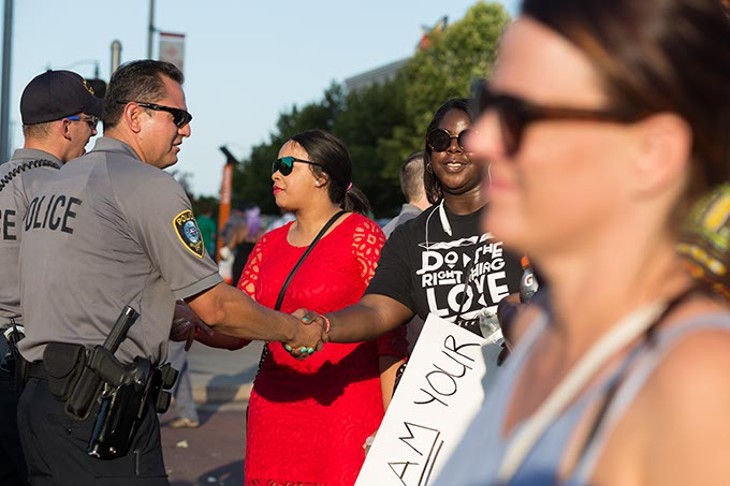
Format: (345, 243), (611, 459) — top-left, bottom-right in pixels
(472, 79), (643, 156)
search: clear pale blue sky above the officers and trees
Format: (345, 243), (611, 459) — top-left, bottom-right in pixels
(5, 0), (517, 195)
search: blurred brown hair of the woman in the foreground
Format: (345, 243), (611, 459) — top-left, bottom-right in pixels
(522, 0), (730, 206)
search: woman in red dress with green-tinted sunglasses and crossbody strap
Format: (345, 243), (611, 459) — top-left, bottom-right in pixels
(238, 130), (407, 486)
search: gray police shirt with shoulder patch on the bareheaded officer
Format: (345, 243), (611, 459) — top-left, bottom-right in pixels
(19, 138), (221, 363)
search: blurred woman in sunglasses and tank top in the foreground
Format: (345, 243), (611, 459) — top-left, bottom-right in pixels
(436, 0), (730, 486)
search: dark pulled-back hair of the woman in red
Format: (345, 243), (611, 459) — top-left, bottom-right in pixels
(289, 129), (372, 215)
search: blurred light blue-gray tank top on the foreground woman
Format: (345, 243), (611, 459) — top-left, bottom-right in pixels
(434, 312), (730, 486)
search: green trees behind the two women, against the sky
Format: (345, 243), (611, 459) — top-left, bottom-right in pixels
(233, 2), (509, 216)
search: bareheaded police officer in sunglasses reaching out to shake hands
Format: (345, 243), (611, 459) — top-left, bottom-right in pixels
(13, 60), (321, 486)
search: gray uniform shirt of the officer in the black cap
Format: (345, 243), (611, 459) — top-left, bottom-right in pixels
(0, 149), (61, 327)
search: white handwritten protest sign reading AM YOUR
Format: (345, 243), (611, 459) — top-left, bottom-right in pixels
(355, 314), (500, 486)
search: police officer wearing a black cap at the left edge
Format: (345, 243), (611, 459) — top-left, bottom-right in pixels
(0, 71), (103, 485)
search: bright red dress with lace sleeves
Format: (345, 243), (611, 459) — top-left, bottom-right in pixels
(238, 214), (407, 486)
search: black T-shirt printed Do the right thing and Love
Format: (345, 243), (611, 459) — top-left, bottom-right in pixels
(366, 206), (522, 334)
